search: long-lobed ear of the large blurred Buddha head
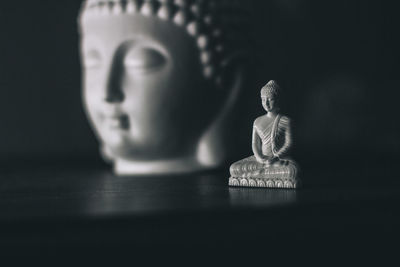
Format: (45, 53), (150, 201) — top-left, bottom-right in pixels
(197, 50), (247, 167)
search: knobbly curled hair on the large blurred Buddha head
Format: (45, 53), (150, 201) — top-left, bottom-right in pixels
(79, 0), (250, 84)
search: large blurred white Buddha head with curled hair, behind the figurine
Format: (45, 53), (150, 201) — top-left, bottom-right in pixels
(79, 0), (250, 174)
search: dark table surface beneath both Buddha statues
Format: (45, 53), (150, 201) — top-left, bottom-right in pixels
(0, 163), (400, 266)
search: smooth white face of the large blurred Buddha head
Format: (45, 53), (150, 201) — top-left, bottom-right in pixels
(81, 14), (218, 161)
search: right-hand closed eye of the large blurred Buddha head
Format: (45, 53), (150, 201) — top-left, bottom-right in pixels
(124, 48), (166, 72)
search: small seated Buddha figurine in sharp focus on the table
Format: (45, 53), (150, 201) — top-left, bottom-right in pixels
(229, 81), (299, 188)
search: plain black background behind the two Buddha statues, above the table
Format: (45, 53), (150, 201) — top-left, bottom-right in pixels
(0, 0), (400, 168)
